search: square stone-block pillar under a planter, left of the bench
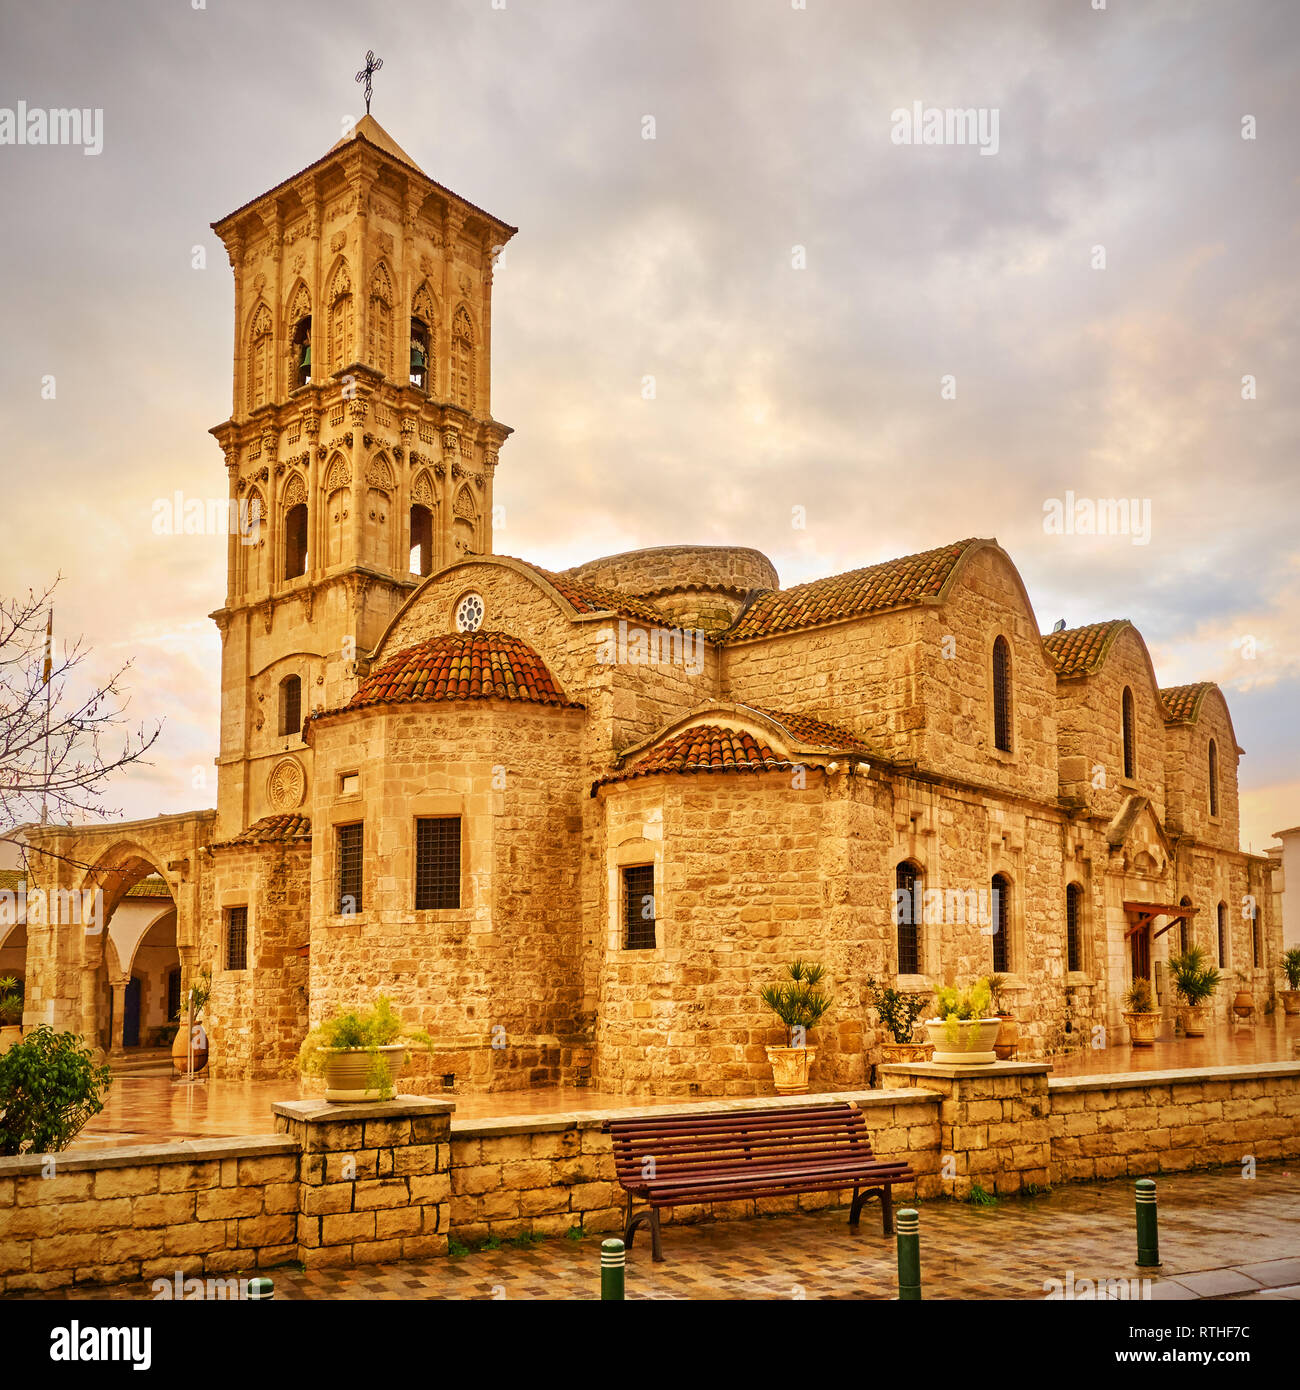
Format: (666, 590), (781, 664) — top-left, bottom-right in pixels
(271, 1095), (456, 1268)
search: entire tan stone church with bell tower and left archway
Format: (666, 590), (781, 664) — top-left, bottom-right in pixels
(12, 115), (1281, 1097)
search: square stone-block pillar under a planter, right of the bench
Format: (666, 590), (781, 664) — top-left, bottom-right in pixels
(880, 1062), (1051, 1197)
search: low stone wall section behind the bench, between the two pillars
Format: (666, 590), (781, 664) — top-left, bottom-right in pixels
(450, 1090), (940, 1243)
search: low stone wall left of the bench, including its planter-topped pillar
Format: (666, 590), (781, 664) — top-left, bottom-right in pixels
(0, 1097), (452, 1291)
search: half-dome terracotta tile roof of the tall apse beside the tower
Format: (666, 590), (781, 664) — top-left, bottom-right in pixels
(343, 632), (581, 717)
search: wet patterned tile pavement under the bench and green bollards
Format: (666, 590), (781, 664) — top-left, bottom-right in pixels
(12, 1165), (1300, 1301)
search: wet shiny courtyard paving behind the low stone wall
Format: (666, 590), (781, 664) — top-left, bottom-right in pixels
(75, 1013), (1300, 1148)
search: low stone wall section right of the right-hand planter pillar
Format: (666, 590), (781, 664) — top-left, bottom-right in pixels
(1048, 1062), (1300, 1183)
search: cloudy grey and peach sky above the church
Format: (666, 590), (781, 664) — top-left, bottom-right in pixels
(0, 0), (1300, 849)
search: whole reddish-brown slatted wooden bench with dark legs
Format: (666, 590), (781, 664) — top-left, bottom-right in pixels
(601, 1102), (916, 1261)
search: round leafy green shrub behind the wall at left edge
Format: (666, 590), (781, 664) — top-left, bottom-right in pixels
(0, 1024), (113, 1158)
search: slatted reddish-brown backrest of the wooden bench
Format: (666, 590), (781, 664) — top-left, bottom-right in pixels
(601, 1101), (872, 1186)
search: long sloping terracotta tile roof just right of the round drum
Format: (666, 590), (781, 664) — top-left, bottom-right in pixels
(724, 541), (976, 642)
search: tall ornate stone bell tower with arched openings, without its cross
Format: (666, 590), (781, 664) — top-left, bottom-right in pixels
(211, 113), (516, 837)
